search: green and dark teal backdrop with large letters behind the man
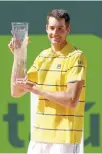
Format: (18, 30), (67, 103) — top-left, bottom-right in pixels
(0, 1), (102, 153)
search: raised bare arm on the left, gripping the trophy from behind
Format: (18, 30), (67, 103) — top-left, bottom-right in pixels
(8, 38), (29, 97)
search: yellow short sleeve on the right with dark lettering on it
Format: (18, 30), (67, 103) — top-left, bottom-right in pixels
(67, 53), (87, 83)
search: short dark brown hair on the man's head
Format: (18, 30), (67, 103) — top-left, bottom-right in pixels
(47, 9), (70, 26)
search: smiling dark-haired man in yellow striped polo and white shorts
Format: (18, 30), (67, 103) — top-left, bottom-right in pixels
(9, 9), (86, 154)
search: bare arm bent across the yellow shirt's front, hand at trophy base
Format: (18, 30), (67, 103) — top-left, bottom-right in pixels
(32, 81), (84, 108)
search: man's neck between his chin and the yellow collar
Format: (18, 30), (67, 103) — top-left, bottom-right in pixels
(51, 40), (67, 52)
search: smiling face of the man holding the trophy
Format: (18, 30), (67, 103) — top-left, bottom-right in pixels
(46, 17), (70, 45)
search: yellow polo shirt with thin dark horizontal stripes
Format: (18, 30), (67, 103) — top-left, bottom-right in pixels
(28, 42), (86, 143)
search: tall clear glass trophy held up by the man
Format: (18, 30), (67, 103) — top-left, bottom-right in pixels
(11, 22), (28, 79)
